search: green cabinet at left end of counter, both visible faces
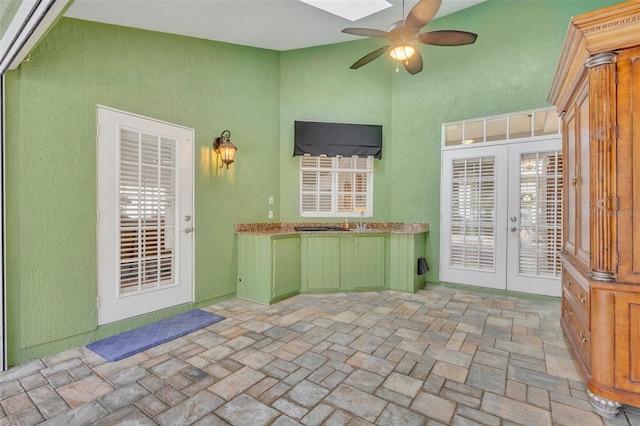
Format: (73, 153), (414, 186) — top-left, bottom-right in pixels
(236, 234), (300, 304)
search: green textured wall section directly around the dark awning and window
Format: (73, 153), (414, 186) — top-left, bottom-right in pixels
(280, 40), (392, 222)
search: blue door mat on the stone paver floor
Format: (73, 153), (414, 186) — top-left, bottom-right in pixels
(87, 309), (224, 361)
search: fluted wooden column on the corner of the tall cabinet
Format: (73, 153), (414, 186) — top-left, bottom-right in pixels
(585, 52), (617, 281)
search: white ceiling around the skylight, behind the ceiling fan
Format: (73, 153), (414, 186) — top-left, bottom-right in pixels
(65, 0), (484, 50)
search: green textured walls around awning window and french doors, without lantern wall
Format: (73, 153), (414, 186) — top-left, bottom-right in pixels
(280, 0), (617, 282)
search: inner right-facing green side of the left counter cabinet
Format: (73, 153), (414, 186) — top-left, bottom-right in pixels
(271, 236), (300, 301)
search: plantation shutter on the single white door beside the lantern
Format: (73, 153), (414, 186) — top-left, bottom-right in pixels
(118, 128), (177, 296)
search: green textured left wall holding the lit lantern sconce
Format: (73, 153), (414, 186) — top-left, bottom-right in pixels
(6, 15), (280, 365)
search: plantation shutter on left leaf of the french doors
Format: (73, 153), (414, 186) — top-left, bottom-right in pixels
(450, 157), (496, 271)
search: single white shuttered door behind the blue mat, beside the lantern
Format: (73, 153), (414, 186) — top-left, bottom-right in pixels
(97, 107), (194, 324)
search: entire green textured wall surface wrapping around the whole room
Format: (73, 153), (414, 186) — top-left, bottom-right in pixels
(1, 0), (615, 365)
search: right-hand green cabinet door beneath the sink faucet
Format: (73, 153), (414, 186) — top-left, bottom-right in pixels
(347, 235), (387, 290)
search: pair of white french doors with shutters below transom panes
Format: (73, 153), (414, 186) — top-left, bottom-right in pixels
(440, 139), (562, 296)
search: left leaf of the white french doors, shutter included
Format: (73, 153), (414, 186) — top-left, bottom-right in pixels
(440, 145), (509, 289)
